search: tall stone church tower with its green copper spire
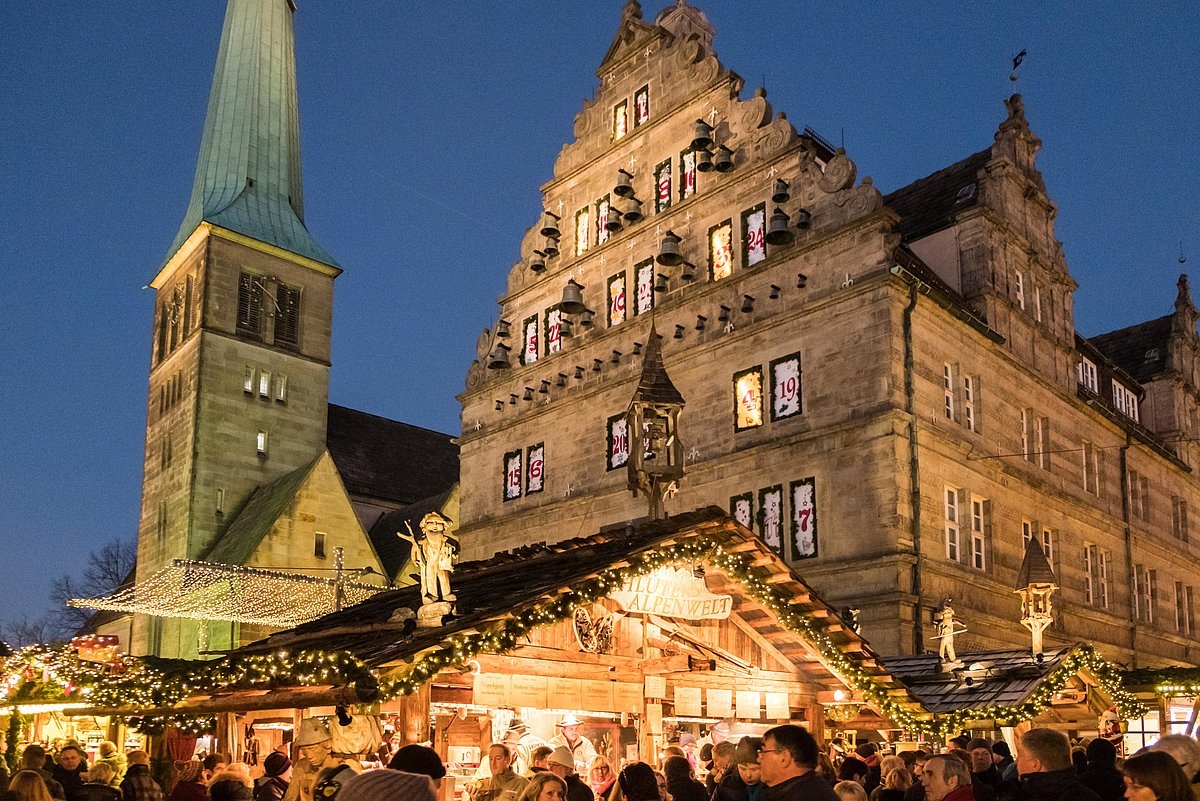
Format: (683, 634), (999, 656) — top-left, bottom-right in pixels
(131, 0), (341, 656)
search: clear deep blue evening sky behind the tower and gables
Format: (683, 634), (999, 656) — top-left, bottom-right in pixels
(0, 0), (1200, 618)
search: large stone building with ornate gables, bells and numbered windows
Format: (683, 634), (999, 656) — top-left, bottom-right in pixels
(460, 1), (1200, 664)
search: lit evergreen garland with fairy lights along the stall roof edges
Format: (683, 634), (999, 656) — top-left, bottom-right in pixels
(0, 538), (1145, 737)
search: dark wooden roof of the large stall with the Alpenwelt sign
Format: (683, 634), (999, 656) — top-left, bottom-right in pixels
(234, 506), (928, 717)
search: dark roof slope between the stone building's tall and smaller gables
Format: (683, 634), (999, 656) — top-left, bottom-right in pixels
(883, 149), (991, 242)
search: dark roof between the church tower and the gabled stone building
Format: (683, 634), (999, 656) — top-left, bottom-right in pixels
(325, 403), (458, 505)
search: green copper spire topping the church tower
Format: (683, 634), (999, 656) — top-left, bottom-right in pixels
(167, 0), (337, 266)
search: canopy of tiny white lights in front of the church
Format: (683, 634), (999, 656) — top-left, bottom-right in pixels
(70, 559), (385, 627)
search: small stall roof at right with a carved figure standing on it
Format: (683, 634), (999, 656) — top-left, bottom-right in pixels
(883, 646), (1075, 713)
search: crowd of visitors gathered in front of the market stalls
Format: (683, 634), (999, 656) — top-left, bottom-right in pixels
(0, 722), (1200, 801)
